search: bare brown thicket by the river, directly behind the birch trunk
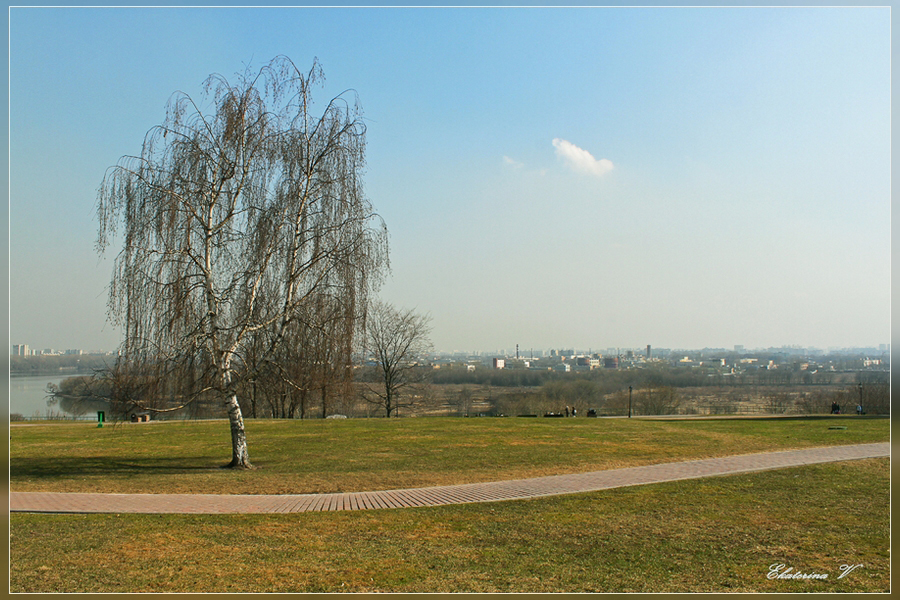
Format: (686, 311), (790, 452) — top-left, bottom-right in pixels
(47, 298), (357, 420)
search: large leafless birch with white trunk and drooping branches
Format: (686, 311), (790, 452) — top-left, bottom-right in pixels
(97, 57), (387, 468)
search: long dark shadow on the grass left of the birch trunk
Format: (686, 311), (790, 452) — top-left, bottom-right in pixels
(9, 456), (227, 481)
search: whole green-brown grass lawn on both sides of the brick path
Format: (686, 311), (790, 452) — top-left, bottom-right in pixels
(10, 417), (890, 593)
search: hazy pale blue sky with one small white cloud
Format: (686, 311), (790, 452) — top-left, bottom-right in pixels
(9, 7), (891, 350)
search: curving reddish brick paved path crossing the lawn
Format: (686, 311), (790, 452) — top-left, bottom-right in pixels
(9, 442), (891, 514)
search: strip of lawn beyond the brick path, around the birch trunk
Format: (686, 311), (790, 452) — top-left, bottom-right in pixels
(10, 416), (890, 494)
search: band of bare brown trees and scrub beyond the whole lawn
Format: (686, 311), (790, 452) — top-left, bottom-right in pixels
(50, 358), (890, 419)
